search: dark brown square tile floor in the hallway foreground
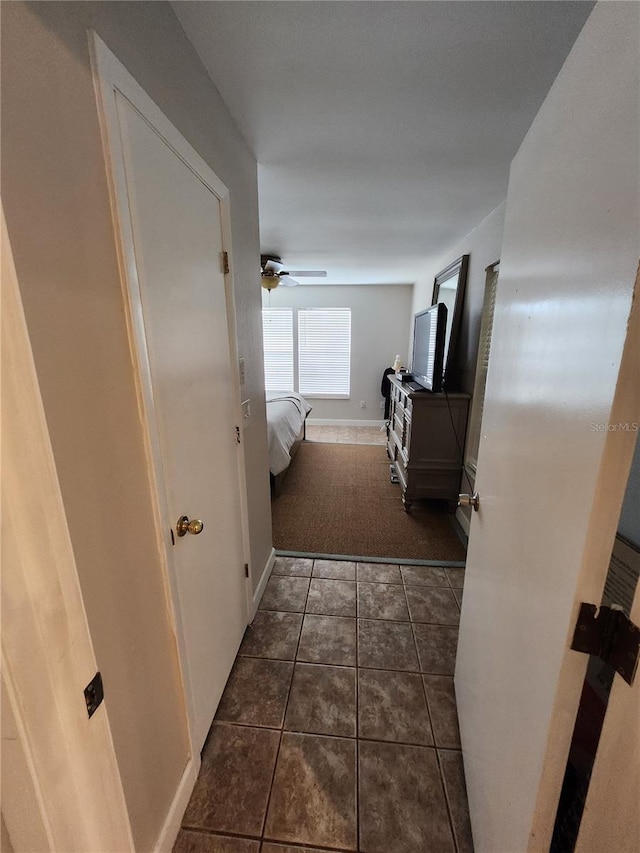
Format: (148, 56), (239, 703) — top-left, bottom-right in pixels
(174, 557), (473, 853)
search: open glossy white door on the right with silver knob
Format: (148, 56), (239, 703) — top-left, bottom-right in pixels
(455, 8), (640, 853)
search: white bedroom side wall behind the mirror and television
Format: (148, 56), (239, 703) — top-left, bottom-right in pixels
(411, 202), (505, 394)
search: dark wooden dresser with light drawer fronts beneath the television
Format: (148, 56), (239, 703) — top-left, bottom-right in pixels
(387, 376), (471, 512)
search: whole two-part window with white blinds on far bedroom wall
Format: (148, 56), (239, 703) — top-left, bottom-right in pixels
(262, 308), (351, 399)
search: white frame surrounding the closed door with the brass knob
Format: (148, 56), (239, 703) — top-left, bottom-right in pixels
(88, 31), (252, 752)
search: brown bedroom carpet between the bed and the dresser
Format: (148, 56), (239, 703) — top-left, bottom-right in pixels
(272, 442), (465, 561)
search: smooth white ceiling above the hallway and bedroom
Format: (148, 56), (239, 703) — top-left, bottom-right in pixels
(173, 0), (593, 284)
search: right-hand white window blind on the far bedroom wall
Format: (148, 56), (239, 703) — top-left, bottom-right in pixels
(298, 308), (351, 398)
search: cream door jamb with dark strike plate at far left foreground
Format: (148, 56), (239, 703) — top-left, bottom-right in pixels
(1, 203), (134, 853)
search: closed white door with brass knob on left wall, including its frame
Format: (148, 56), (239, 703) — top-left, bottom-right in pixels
(92, 36), (247, 750)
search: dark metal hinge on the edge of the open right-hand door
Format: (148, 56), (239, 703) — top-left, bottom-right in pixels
(571, 602), (640, 684)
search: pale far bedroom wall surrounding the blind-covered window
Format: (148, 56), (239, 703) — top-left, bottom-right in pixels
(263, 284), (413, 421)
